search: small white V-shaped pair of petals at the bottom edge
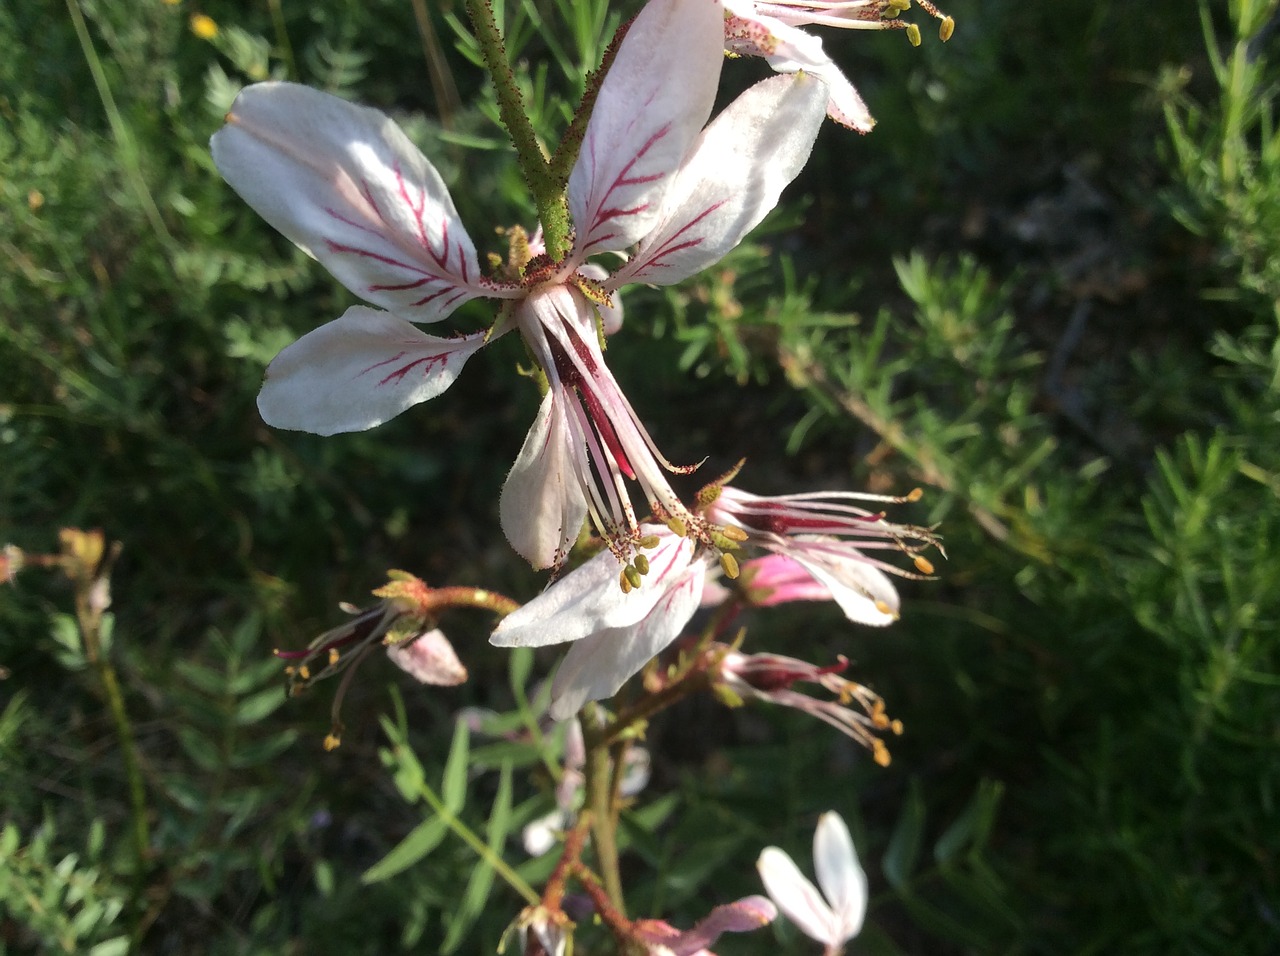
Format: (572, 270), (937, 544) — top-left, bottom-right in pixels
(755, 811), (867, 956)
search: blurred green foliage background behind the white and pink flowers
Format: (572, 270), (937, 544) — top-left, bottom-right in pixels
(0, 0), (1280, 956)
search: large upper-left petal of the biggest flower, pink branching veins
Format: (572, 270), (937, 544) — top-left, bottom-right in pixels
(210, 83), (516, 323)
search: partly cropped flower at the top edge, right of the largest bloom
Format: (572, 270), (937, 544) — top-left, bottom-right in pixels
(724, 0), (955, 133)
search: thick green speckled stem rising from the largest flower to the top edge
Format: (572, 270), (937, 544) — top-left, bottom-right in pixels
(466, 0), (572, 260)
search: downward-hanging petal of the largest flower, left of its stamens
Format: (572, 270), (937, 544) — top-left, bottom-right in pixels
(498, 388), (586, 568)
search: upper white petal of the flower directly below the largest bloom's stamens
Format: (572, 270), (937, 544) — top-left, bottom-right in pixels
(489, 525), (694, 648)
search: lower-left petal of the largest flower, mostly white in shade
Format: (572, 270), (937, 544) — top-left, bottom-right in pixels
(257, 306), (484, 435)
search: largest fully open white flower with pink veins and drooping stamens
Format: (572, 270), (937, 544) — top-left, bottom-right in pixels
(211, 0), (827, 567)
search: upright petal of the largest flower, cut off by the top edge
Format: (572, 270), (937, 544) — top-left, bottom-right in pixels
(568, 0), (724, 261)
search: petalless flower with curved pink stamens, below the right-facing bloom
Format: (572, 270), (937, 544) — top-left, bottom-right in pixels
(716, 650), (902, 767)
